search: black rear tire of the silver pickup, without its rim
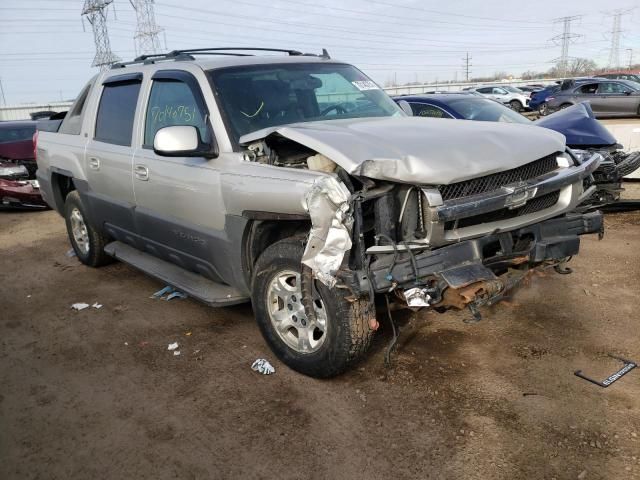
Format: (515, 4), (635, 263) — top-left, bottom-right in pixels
(64, 190), (113, 267)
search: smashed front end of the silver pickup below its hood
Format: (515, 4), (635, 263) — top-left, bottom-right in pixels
(241, 120), (603, 318)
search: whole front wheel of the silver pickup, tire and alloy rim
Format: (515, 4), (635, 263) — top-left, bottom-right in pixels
(252, 238), (375, 378)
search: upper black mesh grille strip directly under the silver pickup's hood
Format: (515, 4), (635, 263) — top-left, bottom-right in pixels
(438, 152), (560, 202)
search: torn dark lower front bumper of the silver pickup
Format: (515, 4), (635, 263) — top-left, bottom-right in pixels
(369, 212), (603, 293)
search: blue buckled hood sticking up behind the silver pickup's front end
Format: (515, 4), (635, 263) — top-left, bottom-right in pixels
(535, 102), (616, 148)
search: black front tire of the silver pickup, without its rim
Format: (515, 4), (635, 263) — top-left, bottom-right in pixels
(252, 238), (375, 378)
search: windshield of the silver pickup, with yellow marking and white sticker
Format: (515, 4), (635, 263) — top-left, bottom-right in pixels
(209, 63), (404, 140)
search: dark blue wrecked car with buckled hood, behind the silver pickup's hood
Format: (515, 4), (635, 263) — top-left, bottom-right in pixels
(394, 93), (640, 207)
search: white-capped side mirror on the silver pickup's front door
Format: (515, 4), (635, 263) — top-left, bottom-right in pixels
(153, 125), (218, 158)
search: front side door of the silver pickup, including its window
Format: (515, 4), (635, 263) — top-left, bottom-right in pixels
(133, 70), (225, 282)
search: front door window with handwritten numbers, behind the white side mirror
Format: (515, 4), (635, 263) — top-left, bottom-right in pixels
(144, 79), (210, 146)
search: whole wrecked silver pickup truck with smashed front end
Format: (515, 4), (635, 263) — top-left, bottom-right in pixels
(37, 49), (603, 377)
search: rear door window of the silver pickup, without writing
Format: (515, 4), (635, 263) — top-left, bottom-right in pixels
(94, 81), (140, 146)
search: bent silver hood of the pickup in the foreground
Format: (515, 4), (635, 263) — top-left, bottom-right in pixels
(240, 117), (565, 185)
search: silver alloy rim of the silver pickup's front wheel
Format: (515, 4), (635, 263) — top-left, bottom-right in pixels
(267, 270), (327, 354)
